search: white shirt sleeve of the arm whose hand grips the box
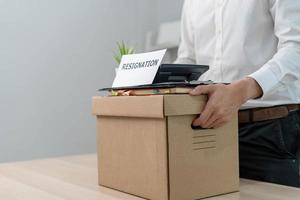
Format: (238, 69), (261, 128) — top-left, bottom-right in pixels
(249, 0), (300, 98)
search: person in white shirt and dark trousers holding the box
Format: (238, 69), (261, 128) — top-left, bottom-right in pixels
(176, 0), (300, 187)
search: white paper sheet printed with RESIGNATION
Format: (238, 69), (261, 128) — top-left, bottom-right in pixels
(112, 49), (167, 87)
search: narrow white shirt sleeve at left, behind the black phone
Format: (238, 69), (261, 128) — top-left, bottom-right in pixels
(175, 0), (196, 64)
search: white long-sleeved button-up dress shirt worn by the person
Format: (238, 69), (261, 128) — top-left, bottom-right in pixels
(176, 0), (300, 108)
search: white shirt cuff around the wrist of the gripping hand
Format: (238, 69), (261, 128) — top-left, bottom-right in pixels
(248, 64), (280, 99)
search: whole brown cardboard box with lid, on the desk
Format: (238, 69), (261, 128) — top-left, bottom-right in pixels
(93, 95), (239, 200)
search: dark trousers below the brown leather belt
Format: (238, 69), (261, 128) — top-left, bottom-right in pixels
(239, 110), (300, 187)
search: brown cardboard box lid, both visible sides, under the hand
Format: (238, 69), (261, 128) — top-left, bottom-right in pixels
(93, 94), (207, 118)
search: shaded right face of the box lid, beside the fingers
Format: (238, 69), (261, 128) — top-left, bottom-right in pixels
(164, 94), (207, 116)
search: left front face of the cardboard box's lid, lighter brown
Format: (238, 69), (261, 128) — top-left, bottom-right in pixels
(92, 95), (164, 118)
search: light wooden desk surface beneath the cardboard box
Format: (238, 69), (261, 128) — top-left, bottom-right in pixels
(0, 154), (300, 200)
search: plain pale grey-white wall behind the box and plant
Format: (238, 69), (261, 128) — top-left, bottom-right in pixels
(0, 0), (183, 162)
